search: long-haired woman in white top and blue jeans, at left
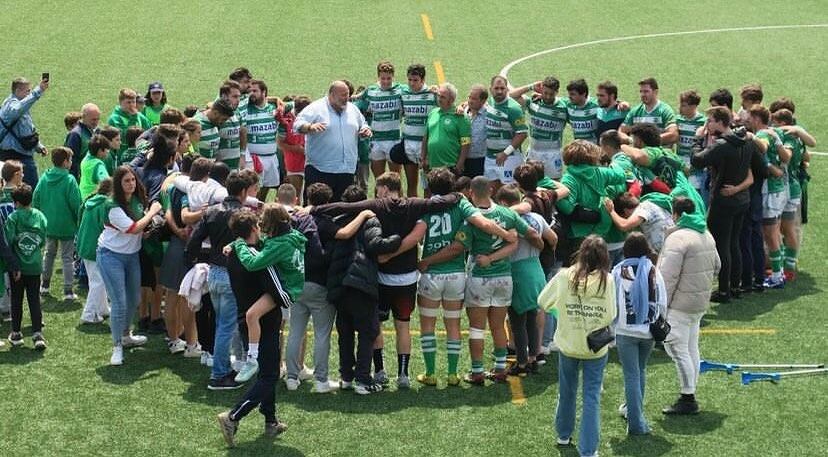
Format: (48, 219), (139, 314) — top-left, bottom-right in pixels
(97, 166), (161, 365)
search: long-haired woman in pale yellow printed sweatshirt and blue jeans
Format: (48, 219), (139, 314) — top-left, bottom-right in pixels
(538, 235), (617, 456)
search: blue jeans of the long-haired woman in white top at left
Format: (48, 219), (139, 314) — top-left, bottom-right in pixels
(97, 247), (141, 346)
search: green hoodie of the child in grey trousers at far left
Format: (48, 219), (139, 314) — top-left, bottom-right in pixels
(32, 167), (81, 240)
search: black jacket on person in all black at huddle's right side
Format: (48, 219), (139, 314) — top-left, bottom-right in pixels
(690, 133), (761, 208)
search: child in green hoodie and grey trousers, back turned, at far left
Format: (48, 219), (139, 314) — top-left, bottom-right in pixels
(32, 146), (81, 300)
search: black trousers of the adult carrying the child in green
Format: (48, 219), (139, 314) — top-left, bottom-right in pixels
(230, 306), (282, 423)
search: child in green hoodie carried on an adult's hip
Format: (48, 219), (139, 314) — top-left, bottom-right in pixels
(232, 203), (307, 382)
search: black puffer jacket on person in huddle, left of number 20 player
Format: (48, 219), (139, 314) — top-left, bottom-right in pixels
(327, 217), (402, 303)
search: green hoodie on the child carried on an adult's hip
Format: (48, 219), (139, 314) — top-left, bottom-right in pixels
(233, 229), (308, 301)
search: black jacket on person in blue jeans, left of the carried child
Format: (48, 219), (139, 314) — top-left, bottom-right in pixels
(187, 197), (244, 268)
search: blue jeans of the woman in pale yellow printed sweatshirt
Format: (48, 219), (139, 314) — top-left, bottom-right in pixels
(555, 353), (607, 456)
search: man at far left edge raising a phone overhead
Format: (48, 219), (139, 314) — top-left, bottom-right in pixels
(0, 73), (49, 188)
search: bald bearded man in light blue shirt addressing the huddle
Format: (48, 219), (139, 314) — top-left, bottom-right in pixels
(293, 81), (371, 201)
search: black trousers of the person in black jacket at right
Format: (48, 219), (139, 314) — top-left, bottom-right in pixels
(707, 204), (747, 295)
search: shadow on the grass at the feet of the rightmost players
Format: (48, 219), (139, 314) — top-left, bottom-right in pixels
(704, 272), (823, 321)
